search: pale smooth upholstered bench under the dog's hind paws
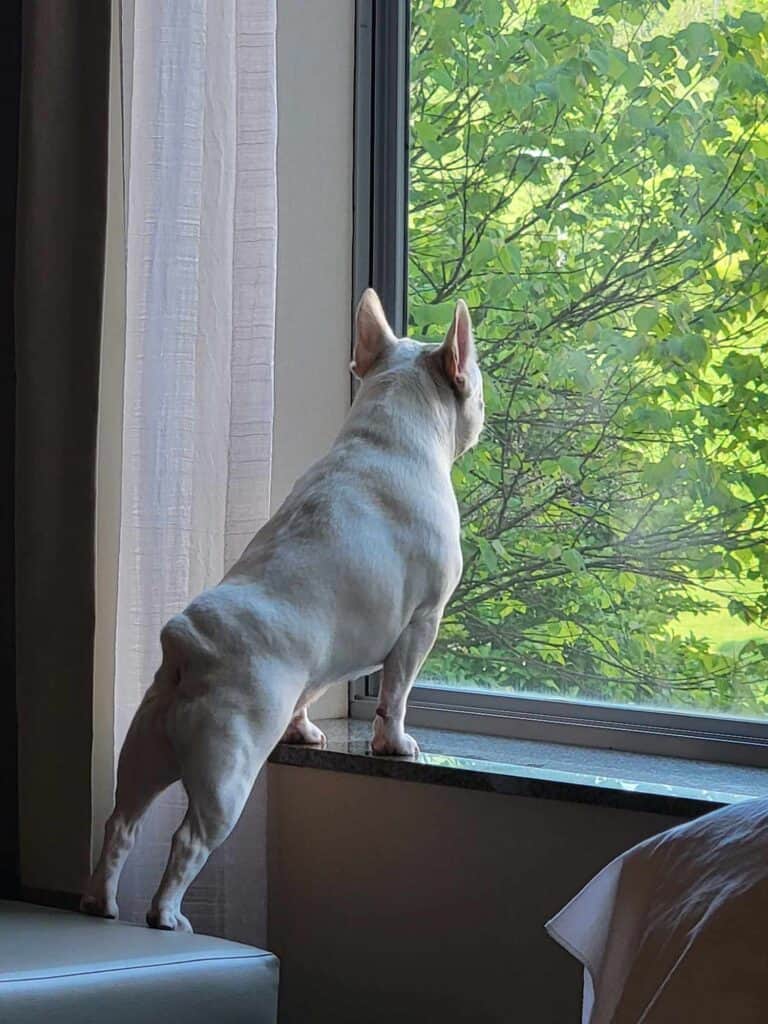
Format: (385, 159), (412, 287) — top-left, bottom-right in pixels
(0, 900), (279, 1024)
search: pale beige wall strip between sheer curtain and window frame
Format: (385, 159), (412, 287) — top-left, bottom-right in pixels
(272, 0), (354, 717)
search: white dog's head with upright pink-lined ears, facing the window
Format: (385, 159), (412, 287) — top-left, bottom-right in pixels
(351, 288), (485, 458)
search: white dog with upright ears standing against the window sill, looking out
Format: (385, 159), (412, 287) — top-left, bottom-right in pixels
(81, 289), (483, 931)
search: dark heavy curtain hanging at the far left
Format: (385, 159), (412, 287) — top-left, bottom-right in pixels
(14, 0), (110, 894)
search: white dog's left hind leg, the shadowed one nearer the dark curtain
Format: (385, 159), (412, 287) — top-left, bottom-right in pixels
(80, 669), (179, 918)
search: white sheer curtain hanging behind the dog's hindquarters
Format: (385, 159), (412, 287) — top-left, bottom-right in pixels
(109, 0), (276, 941)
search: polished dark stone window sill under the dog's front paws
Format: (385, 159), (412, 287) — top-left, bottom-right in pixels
(269, 719), (768, 818)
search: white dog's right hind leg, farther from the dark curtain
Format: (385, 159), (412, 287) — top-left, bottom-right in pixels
(146, 694), (295, 931)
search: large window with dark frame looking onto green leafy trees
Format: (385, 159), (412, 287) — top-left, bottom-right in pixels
(355, 0), (768, 761)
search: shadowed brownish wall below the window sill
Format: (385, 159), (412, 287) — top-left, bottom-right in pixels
(268, 765), (676, 1024)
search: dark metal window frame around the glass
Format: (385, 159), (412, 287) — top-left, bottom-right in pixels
(349, 0), (768, 768)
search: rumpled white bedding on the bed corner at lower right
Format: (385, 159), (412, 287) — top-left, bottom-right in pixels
(547, 798), (768, 1024)
